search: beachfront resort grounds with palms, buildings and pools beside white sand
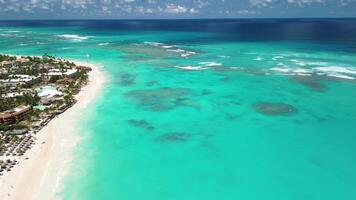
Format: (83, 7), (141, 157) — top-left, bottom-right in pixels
(0, 55), (91, 177)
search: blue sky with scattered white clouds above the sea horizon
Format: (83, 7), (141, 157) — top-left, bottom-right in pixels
(0, 0), (356, 20)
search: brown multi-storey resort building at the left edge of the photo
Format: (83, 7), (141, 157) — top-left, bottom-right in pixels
(0, 106), (31, 125)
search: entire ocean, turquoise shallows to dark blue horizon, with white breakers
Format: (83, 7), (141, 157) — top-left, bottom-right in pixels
(0, 19), (356, 200)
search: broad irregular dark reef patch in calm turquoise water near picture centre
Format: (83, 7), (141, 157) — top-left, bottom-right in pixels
(126, 88), (191, 111)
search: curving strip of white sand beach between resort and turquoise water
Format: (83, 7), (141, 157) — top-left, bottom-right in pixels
(0, 60), (106, 200)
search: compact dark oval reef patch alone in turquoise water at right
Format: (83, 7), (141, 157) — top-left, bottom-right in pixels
(253, 102), (297, 116)
